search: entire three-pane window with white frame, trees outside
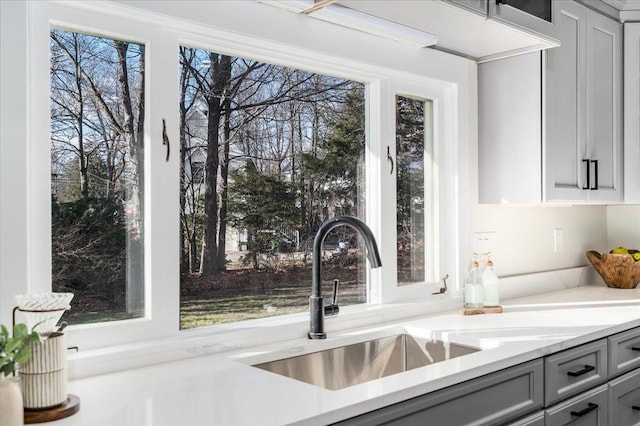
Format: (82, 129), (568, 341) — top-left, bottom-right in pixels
(10, 1), (470, 351)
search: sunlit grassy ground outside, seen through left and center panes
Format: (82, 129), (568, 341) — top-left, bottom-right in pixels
(58, 253), (366, 329)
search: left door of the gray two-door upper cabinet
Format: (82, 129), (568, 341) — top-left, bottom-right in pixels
(543, 1), (586, 202)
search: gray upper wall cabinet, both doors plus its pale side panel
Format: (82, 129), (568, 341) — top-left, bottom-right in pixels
(478, 1), (620, 204)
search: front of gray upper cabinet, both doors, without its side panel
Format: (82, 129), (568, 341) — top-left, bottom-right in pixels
(543, 1), (623, 203)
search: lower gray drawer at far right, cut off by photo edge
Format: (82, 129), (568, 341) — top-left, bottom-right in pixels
(609, 369), (640, 426)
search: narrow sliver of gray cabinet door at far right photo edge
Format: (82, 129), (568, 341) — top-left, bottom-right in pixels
(624, 22), (640, 203)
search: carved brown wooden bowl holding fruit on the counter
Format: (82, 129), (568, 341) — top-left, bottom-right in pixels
(587, 250), (640, 288)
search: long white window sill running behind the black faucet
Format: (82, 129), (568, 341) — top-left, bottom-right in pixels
(68, 295), (462, 379)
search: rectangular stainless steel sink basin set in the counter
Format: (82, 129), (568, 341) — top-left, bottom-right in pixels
(254, 333), (480, 390)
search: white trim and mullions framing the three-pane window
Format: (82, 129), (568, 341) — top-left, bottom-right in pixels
(2, 1), (476, 370)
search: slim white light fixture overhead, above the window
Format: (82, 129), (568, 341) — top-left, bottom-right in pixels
(261, 0), (438, 47)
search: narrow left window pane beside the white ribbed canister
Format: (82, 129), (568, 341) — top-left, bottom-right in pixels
(50, 29), (145, 324)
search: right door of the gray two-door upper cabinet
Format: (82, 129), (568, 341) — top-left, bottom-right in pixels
(584, 9), (623, 202)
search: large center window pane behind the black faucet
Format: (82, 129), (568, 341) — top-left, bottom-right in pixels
(179, 46), (366, 328)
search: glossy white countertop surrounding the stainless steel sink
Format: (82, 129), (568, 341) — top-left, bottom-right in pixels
(52, 286), (640, 426)
